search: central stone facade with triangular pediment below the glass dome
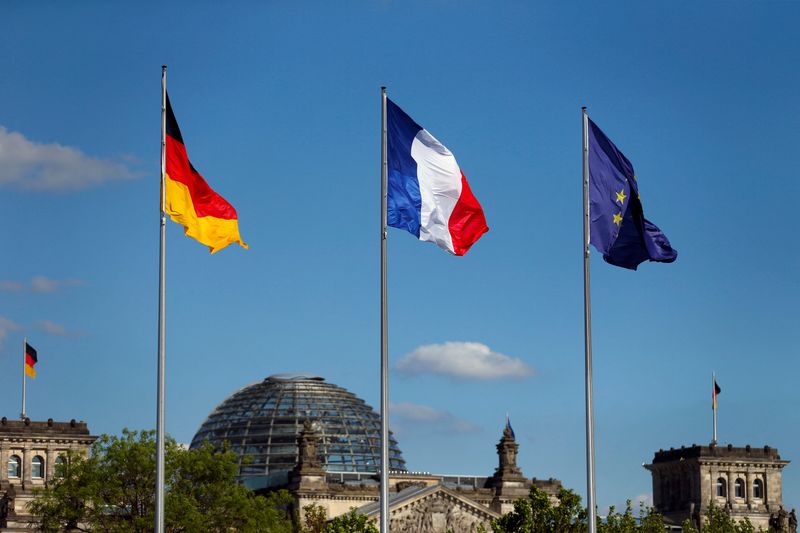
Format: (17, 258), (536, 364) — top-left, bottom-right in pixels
(284, 422), (561, 533)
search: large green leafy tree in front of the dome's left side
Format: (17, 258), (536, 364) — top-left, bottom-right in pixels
(29, 430), (292, 533)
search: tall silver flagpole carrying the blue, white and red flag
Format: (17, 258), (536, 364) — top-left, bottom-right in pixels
(380, 87), (389, 533)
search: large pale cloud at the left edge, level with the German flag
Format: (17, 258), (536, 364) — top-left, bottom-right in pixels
(0, 126), (134, 192)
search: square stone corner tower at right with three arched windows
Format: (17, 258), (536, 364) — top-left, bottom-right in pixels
(644, 444), (789, 530)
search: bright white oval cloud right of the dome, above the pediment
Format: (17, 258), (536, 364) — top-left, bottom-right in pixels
(395, 342), (533, 379)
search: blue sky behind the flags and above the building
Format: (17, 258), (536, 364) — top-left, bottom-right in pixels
(0, 0), (800, 507)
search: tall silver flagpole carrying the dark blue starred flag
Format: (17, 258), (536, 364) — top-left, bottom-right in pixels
(581, 107), (597, 533)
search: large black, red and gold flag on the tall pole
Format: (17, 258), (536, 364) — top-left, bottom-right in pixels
(164, 92), (247, 254)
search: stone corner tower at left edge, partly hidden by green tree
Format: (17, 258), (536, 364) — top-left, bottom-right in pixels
(0, 417), (96, 532)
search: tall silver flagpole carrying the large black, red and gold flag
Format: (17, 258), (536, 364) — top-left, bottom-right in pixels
(155, 65), (167, 533)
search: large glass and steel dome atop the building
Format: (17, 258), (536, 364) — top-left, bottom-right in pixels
(191, 374), (406, 488)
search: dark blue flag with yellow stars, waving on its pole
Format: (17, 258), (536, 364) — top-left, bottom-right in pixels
(589, 120), (678, 270)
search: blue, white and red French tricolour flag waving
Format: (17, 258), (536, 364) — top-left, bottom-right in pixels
(386, 98), (489, 255)
